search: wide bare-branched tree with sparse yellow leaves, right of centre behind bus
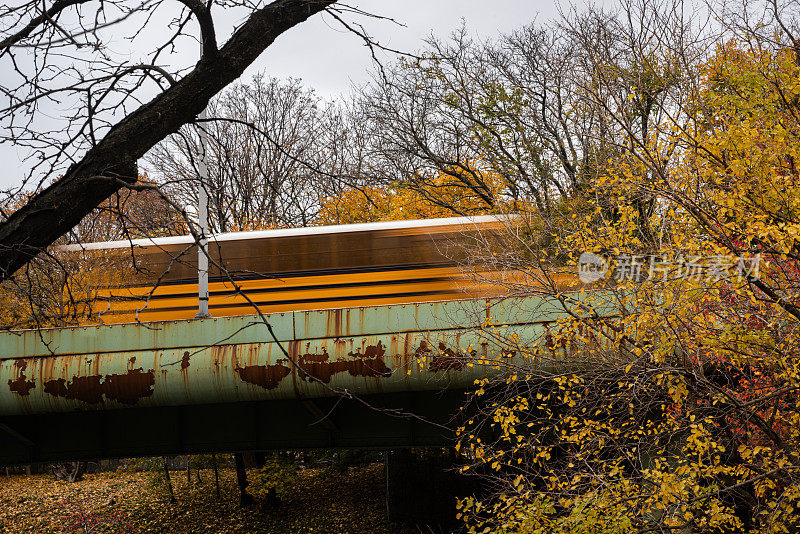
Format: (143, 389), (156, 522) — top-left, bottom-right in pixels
(360, 0), (705, 224)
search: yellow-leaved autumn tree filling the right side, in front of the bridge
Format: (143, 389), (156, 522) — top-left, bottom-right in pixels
(444, 2), (800, 533)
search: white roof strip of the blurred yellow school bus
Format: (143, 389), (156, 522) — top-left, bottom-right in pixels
(56, 215), (515, 251)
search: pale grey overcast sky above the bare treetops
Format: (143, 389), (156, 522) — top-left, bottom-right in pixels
(0, 0), (564, 188)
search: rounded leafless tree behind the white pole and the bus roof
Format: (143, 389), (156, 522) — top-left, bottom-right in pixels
(147, 76), (343, 232)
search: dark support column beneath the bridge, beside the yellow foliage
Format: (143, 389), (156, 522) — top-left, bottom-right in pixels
(385, 449), (475, 527)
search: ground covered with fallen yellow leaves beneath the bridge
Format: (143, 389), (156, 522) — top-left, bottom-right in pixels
(0, 464), (414, 534)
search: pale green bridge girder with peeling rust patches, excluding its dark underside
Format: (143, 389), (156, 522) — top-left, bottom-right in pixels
(0, 298), (612, 416)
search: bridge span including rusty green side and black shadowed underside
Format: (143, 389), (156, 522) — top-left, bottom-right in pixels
(0, 297), (600, 464)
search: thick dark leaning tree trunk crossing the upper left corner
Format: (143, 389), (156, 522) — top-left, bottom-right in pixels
(0, 0), (336, 282)
